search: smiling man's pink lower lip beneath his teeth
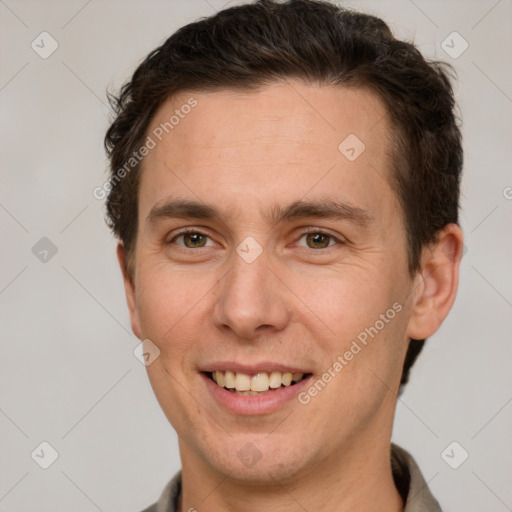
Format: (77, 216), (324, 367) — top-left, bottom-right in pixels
(201, 373), (313, 416)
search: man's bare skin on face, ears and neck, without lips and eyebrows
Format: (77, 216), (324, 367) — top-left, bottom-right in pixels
(118, 81), (462, 512)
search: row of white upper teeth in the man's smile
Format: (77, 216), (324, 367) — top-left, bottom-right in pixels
(212, 370), (304, 391)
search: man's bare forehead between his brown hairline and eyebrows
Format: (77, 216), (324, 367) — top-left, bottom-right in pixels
(139, 81), (396, 224)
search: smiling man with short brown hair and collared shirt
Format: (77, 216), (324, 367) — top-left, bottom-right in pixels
(105, 0), (463, 512)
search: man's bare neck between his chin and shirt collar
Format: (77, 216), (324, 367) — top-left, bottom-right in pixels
(178, 438), (404, 512)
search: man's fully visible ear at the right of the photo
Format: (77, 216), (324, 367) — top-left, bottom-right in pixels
(407, 224), (464, 340)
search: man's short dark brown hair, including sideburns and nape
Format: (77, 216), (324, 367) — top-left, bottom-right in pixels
(105, 0), (462, 385)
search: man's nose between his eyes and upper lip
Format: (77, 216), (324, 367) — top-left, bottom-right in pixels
(213, 251), (291, 340)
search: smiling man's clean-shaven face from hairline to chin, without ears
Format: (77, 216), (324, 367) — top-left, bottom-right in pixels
(122, 81), (422, 482)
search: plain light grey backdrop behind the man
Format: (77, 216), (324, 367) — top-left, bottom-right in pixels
(0, 0), (512, 512)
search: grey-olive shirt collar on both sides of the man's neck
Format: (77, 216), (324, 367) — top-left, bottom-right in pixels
(142, 444), (441, 512)
